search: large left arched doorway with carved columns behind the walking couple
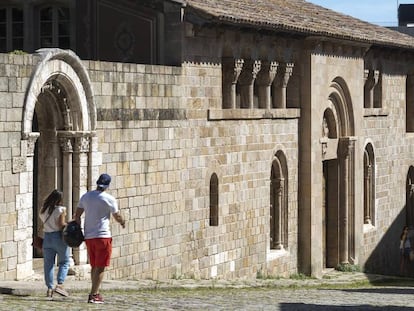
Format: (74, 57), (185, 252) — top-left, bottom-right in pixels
(22, 49), (97, 263)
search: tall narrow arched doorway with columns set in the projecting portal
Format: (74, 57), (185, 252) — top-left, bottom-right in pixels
(320, 78), (355, 268)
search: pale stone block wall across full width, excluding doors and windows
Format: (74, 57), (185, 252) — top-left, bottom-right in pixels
(0, 44), (414, 280)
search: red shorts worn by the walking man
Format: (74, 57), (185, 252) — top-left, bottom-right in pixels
(85, 238), (112, 267)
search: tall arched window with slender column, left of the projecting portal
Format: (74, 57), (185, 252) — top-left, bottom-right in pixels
(270, 151), (288, 249)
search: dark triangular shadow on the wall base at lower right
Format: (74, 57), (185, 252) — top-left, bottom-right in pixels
(364, 207), (414, 277)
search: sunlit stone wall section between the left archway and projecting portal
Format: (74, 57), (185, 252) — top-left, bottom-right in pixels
(86, 62), (297, 278)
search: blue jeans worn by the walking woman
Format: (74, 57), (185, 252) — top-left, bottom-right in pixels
(43, 231), (70, 288)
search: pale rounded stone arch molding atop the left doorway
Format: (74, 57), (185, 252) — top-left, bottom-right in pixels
(22, 49), (96, 140)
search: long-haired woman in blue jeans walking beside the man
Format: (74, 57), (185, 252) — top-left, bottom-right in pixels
(39, 190), (69, 297)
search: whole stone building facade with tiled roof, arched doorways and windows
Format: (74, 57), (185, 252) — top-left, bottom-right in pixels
(0, 0), (414, 280)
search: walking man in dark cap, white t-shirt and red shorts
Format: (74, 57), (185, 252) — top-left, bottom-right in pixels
(75, 174), (125, 303)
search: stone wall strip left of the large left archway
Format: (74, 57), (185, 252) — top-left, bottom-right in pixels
(0, 54), (35, 280)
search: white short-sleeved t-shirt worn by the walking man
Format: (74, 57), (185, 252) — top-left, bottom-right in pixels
(79, 190), (119, 239)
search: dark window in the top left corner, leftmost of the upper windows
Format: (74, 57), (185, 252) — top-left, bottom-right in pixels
(0, 8), (24, 53)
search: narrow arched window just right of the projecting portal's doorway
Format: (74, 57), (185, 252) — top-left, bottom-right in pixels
(364, 144), (375, 225)
